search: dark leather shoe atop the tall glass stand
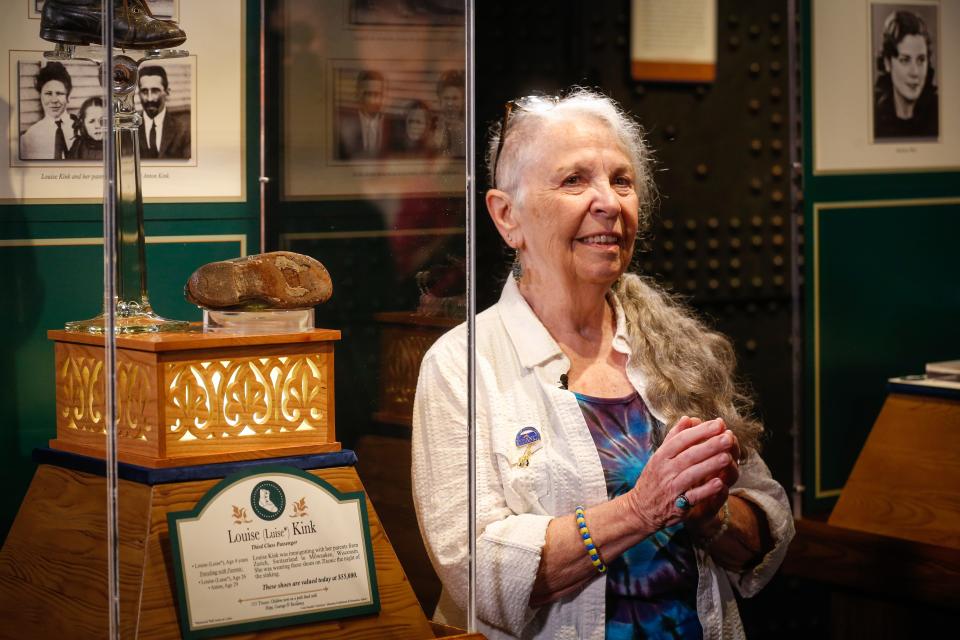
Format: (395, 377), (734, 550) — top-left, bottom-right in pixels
(40, 0), (187, 49)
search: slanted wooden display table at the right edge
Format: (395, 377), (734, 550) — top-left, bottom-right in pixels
(781, 385), (960, 640)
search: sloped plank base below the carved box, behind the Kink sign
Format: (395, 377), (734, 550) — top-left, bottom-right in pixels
(0, 450), (450, 640)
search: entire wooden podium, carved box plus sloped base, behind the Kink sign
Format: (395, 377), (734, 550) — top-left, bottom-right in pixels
(0, 329), (480, 640)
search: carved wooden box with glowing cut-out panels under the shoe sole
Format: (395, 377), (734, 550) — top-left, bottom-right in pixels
(48, 329), (340, 467)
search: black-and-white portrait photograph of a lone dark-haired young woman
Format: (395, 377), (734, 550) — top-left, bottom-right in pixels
(870, 2), (940, 142)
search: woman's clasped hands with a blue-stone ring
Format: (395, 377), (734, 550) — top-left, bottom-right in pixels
(631, 416), (740, 536)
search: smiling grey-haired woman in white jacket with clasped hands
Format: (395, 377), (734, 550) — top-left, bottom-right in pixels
(413, 89), (793, 639)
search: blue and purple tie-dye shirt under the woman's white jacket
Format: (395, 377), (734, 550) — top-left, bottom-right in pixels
(574, 393), (703, 640)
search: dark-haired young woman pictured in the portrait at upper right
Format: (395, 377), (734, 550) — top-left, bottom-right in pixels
(873, 11), (940, 139)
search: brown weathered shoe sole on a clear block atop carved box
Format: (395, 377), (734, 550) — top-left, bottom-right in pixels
(184, 251), (333, 309)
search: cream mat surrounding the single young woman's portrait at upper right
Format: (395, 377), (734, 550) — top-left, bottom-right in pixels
(811, 0), (960, 174)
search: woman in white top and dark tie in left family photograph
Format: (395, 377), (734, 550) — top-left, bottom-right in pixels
(20, 62), (76, 160)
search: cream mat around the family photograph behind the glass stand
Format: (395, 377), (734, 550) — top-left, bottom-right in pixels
(0, 0), (246, 203)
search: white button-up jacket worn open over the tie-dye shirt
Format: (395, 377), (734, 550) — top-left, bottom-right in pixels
(413, 279), (794, 640)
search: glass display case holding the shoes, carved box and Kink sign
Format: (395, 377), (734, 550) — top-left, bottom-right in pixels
(0, 0), (472, 638)
